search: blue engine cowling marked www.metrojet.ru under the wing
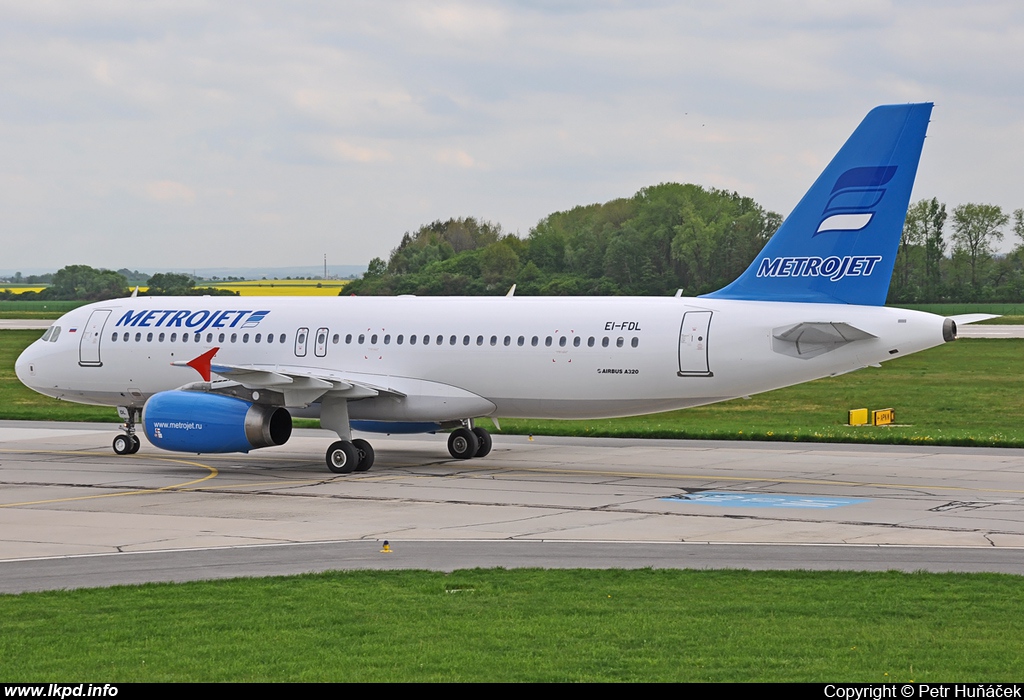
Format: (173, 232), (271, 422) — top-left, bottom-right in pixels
(142, 390), (292, 453)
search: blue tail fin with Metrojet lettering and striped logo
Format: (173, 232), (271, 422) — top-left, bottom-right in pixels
(706, 102), (932, 306)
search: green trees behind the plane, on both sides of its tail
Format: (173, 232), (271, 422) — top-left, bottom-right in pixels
(350, 183), (1024, 303)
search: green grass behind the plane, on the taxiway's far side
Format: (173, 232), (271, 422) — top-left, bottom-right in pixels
(6, 331), (1024, 447)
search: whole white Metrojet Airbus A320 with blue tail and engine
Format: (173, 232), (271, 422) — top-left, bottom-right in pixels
(15, 102), (958, 474)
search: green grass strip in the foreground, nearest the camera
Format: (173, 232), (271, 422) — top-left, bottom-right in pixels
(0, 569), (1024, 683)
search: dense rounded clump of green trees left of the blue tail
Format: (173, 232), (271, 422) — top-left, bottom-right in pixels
(343, 183), (782, 295)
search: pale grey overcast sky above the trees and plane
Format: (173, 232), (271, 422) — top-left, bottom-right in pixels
(0, 0), (1024, 269)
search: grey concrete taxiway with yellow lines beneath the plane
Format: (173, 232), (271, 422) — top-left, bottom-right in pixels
(0, 422), (1024, 593)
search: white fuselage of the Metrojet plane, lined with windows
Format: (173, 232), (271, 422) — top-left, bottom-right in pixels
(16, 297), (944, 421)
